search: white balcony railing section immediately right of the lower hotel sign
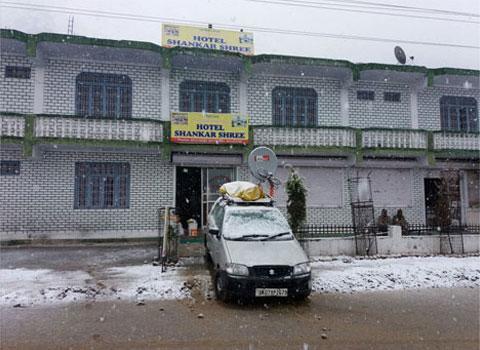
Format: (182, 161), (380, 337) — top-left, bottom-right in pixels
(253, 126), (356, 147)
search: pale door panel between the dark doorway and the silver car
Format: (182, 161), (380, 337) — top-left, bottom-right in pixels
(202, 168), (235, 226)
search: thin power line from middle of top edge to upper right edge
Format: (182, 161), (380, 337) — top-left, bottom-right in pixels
(243, 0), (480, 24)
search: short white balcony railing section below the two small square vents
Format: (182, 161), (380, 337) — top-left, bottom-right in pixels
(362, 129), (428, 149)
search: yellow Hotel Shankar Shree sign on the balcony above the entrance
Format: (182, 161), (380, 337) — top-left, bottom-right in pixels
(170, 112), (249, 145)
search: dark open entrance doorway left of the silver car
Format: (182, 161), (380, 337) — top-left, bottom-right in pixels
(175, 166), (202, 232)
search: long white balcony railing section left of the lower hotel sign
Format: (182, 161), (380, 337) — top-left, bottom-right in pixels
(35, 116), (163, 142)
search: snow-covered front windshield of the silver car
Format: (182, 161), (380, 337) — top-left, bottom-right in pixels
(223, 208), (292, 239)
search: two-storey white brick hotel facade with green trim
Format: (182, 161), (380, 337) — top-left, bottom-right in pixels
(0, 30), (480, 240)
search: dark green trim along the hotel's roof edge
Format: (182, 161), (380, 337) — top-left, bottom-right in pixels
(0, 29), (480, 79)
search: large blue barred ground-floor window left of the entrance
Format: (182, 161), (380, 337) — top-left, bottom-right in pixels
(75, 162), (130, 209)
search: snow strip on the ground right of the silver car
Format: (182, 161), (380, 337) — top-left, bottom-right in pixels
(312, 257), (480, 293)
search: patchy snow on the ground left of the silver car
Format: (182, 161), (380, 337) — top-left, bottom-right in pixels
(0, 265), (190, 306)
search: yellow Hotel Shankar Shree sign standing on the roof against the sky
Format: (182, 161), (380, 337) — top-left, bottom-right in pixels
(162, 24), (254, 55)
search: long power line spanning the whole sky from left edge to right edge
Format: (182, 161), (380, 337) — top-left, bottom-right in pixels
(0, 1), (480, 49)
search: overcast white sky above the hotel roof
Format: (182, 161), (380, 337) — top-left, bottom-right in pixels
(0, 0), (480, 69)
